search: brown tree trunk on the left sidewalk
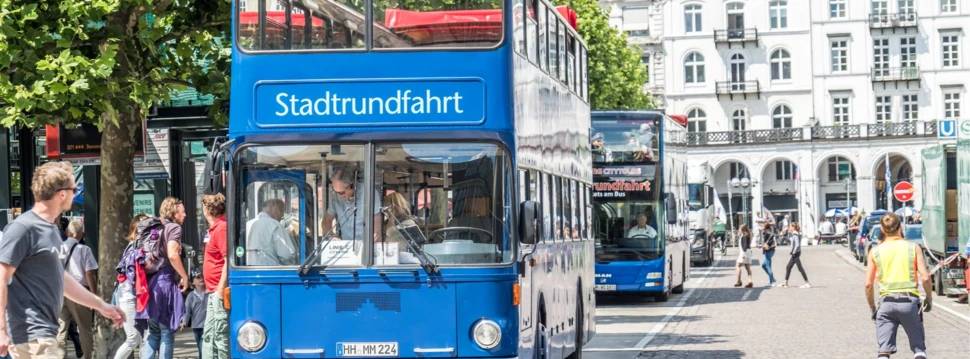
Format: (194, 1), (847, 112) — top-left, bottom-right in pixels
(92, 106), (141, 359)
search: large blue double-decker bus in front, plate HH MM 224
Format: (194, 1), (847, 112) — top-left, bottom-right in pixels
(207, 0), (595, 359)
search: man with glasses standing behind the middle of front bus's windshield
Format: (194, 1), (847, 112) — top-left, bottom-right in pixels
(320, 167), (382, 241)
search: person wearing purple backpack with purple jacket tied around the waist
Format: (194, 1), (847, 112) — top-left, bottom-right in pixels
(138, 197), (189, 359)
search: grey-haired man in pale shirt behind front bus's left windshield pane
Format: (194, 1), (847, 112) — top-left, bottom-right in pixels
(246, 199), (299, 266)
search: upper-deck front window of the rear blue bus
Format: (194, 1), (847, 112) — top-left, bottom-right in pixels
(592, 118), (660, 163)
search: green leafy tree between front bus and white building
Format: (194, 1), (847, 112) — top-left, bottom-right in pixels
(553, 0), (654, 110)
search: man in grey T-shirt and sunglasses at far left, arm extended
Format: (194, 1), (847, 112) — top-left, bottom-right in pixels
(0, 162), (125, 359)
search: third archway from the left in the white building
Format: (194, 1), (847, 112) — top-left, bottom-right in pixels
(813, 155), (856, 223)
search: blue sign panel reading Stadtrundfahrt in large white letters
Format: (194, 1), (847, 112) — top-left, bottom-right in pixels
(255, 79), (485, 127)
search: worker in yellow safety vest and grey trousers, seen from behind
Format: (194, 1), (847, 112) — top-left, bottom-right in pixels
(866, 213), (933, 359)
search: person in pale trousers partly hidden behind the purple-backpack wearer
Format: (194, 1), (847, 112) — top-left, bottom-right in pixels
(115, 214), (148, 359)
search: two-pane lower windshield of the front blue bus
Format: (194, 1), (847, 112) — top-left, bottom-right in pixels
(235, 143), (512, 267)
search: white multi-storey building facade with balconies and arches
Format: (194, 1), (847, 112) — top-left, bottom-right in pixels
(603, 0), (970, 235)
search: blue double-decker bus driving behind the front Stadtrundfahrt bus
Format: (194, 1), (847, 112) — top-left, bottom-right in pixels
(592, 111), (691, 302)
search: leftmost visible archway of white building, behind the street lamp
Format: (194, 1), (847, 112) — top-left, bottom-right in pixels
(714, 161), (758, 228)
